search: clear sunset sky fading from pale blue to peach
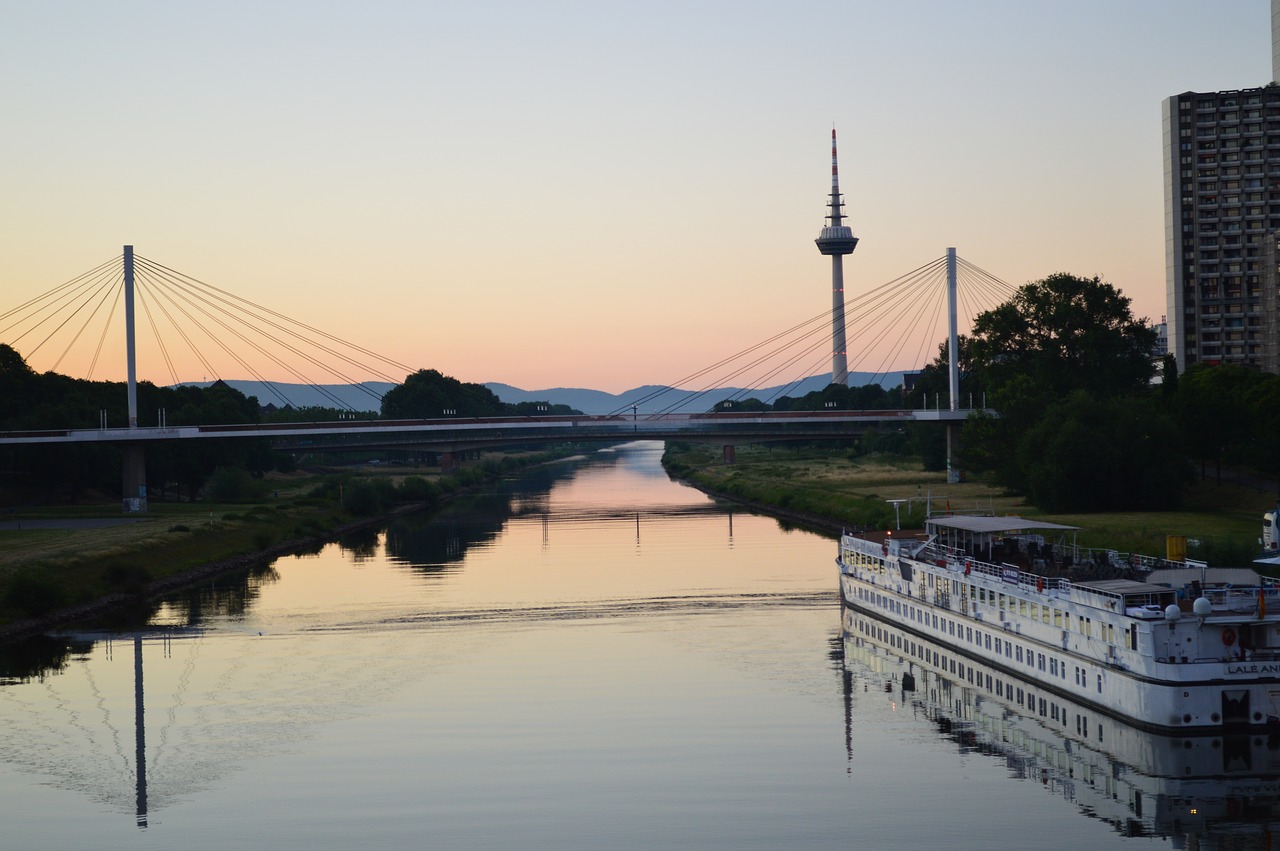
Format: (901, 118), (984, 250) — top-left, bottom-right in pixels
(0, 0), (1271, 392)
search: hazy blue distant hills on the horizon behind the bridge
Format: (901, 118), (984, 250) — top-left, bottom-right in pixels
(189, 372), (902, 413)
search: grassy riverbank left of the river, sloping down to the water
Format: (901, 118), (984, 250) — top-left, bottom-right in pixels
(0, 450), (570, 628)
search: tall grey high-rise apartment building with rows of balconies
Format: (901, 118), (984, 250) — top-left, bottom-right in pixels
(1164, 0), (1280, 371)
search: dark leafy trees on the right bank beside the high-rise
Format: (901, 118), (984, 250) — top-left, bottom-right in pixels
(732, 273), (1280, 512)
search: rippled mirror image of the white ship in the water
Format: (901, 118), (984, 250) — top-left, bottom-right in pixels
(842, 608), (1280, 848)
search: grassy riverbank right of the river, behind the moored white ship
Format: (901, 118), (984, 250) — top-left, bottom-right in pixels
(663, 444), (1275, 564)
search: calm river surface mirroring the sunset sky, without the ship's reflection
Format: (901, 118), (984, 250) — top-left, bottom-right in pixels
(0, 444), (1280, 851)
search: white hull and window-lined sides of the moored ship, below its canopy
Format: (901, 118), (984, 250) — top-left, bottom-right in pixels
(838, 518), (1280, 732)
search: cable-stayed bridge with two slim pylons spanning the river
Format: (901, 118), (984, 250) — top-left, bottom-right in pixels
(0, 246), (1012, 497)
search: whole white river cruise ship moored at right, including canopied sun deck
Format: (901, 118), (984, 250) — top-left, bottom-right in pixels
(837, 516), (1280, 732)
